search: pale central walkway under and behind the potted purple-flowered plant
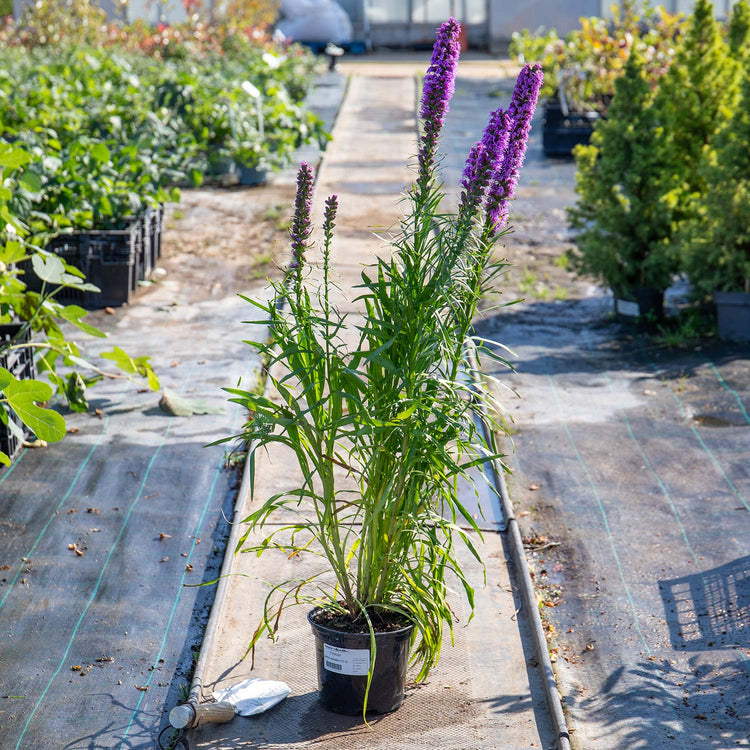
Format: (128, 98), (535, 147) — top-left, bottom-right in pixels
(189, 66), (554, 750)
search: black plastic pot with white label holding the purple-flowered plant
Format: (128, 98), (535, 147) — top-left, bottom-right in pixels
(307, 609), (414, 716)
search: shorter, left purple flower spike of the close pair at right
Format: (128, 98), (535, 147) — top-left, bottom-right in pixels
(458, 109), (510, 223)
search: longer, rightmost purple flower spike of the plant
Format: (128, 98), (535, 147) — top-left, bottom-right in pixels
(485, 63), (544, 232)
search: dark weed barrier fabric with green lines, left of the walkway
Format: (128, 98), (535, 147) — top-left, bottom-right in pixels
(0, 286), (262, 748)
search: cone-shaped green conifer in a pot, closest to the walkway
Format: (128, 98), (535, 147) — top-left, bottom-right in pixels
(568, 52), (679, 317)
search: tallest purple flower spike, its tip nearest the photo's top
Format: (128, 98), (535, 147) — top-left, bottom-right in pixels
(419, 18), (461, 186)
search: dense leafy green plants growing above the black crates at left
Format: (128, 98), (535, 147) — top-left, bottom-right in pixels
(0, 40), (324, 241)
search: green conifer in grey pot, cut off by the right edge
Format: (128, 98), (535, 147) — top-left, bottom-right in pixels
(682, 54), (750, 341)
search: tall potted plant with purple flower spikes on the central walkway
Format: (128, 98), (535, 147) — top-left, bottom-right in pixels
(220, 19), (542, 715)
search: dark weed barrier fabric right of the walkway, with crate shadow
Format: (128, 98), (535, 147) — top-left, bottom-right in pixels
(478, 302), (750, 750)
